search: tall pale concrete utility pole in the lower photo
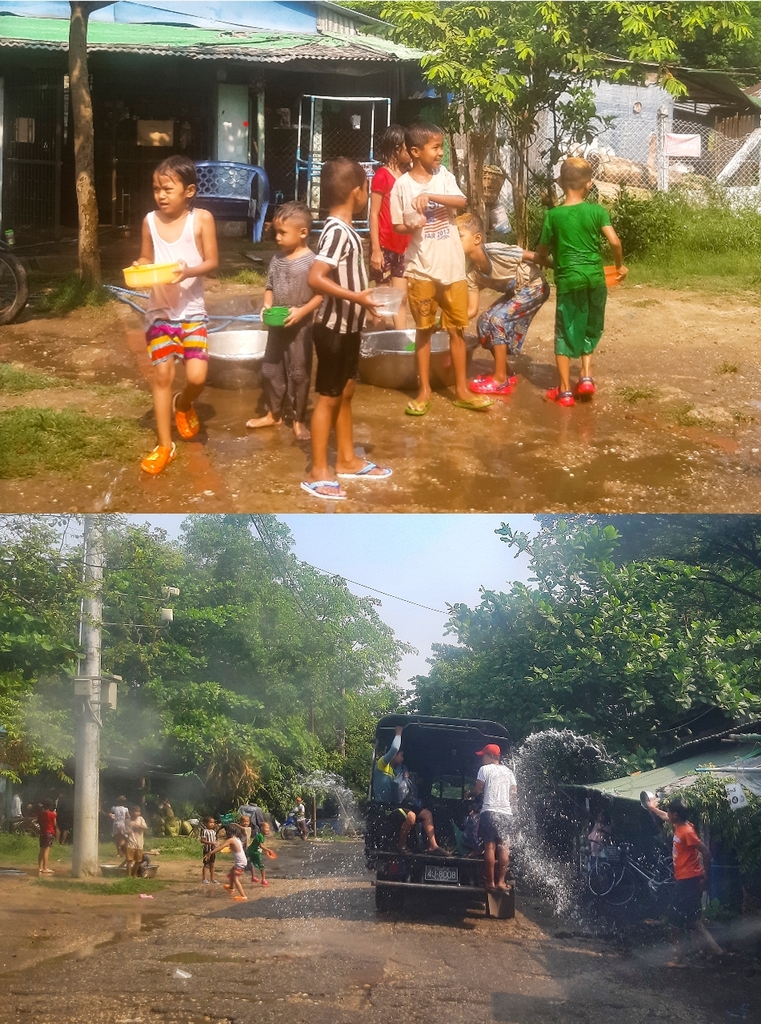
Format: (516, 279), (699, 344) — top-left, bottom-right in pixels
(72, 515), (104, 879)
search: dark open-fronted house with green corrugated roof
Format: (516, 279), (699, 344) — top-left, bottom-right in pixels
(0, 0), (425, 238)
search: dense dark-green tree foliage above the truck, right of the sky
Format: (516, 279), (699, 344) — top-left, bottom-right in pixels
(416, 519), (761, 768)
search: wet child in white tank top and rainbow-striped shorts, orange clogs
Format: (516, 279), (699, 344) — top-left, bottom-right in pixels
(134, 155), (219, 476)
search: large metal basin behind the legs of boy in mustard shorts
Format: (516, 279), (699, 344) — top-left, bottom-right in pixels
(360, 331), (478, 391)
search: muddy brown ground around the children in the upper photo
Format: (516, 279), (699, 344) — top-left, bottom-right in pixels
(0, 238), (761, 513)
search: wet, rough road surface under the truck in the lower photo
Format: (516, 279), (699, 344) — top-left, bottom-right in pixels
(0, 842), (761, 1024)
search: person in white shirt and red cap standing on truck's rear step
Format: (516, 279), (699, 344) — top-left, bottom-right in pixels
(475, 743), (518, 889)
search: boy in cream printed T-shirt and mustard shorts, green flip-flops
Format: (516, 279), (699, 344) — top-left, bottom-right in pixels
(390, 122), (492, 416)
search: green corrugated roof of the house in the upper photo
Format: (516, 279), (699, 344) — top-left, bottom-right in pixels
(0, 14), (421, 62)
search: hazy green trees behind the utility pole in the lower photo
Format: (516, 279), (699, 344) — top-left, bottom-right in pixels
(0, 515), (408, 810)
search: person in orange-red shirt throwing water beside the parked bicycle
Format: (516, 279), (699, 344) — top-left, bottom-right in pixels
(647, 797), (724, 967)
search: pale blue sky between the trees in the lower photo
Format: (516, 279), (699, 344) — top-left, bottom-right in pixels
(129, 514), (537, 685)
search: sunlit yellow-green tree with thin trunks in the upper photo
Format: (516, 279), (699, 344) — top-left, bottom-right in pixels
(360, 0), (754, 245)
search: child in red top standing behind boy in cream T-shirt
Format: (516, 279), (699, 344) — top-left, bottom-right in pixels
(370, 125), (410, 331)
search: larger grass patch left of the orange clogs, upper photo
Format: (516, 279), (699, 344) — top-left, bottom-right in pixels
(0, 409), (140, 480)
